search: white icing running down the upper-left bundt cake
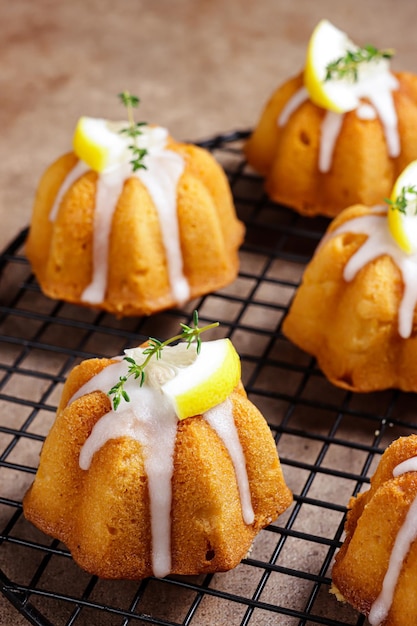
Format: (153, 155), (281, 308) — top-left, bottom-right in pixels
(49, 127), (190, 304)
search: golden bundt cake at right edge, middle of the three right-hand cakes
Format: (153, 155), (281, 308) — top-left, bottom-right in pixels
(283, 193), (417, 392)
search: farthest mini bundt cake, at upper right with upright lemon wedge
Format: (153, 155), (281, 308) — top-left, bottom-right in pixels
(245, 20), (417, 217)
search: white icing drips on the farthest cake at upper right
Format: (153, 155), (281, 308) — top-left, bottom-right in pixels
(278, 72), (401, 173)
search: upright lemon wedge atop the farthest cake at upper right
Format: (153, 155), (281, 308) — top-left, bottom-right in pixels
(304, 20), (388, 113)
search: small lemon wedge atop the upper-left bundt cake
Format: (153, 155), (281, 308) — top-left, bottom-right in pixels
(72, 117), (127, 172)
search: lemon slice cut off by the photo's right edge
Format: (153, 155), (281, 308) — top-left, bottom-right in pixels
(388, 161), (417, 254)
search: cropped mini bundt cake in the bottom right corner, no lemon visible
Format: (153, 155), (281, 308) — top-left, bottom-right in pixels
(332, 435), (417, 626)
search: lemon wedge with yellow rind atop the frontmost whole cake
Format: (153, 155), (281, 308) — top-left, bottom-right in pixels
(161, 339), (241, 420)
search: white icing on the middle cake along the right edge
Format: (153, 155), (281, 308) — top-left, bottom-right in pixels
(329, 207), (417, 339)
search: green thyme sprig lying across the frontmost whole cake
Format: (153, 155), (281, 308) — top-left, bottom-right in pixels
(107, 311), (219, 411)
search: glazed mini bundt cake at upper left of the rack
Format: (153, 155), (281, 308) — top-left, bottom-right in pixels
(26, 100), (244, 316)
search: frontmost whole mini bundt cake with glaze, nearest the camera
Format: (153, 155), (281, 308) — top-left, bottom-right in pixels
(24, 324), (292, 579)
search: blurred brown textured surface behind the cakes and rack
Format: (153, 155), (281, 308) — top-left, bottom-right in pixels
(0, 0), (417, 626)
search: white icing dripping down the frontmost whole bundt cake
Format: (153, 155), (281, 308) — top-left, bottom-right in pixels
(69, 357), (254, 578)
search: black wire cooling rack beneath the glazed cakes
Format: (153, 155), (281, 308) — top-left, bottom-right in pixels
(0, 132), (417, 626)
